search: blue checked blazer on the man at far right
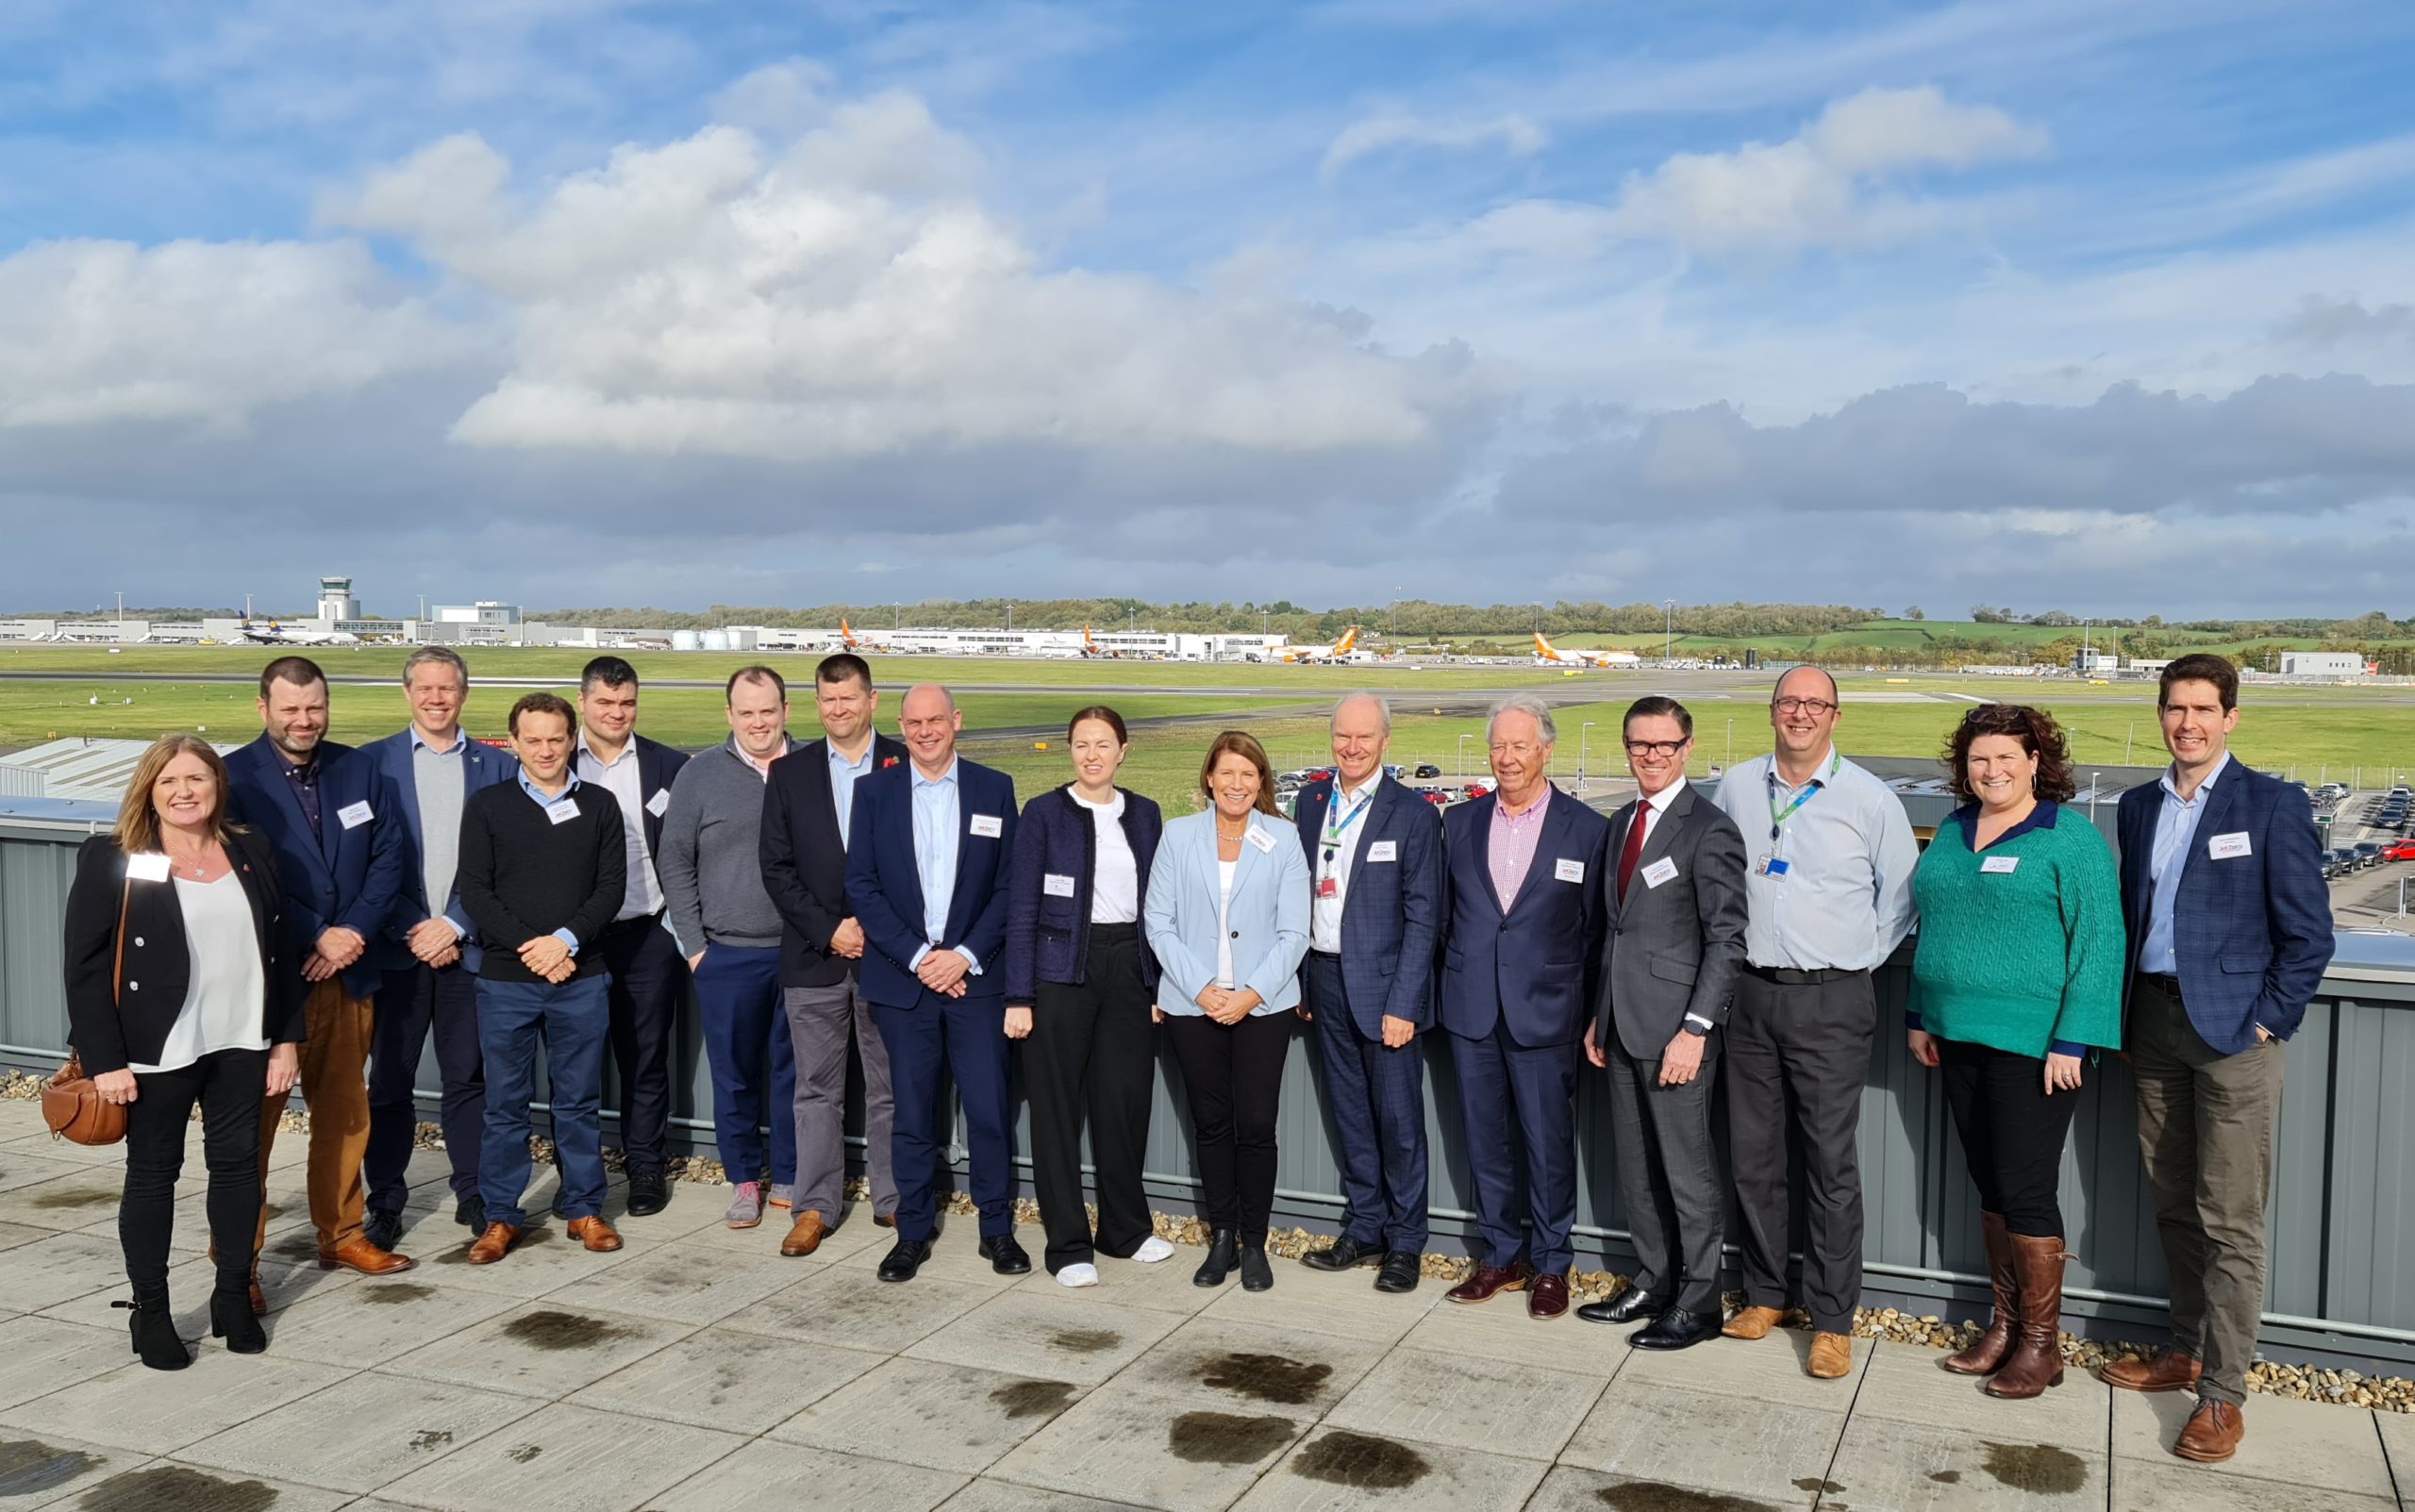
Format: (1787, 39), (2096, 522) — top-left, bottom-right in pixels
(2116, 756), (2338, 1055)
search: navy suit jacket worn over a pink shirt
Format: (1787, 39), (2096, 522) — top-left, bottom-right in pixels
(1441, 789), (1611, 1048)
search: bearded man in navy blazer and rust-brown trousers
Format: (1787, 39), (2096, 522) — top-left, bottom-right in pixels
(227, 657), (410, 1275)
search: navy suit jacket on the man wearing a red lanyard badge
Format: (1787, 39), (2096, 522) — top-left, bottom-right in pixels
(1292, 775), (1441, 1041)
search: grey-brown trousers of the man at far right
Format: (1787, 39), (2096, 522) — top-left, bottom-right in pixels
(2127, 981), (2282, 1405)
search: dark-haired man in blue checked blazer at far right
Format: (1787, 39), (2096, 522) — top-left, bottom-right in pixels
(2104, 655), (2333, 1464)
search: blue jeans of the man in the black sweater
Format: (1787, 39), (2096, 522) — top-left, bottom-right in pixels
(478, 973), (611, 1229)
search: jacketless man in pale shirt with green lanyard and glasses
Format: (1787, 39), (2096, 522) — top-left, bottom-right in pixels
(1720, 667), (1920, 1379)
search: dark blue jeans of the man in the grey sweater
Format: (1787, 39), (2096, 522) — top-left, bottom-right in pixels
(695, 944), (797, 1186)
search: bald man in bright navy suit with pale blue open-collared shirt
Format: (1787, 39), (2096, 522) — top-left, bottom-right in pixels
(848, 684), (1031, 1280)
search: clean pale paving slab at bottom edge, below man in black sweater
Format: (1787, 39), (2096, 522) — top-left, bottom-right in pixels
(367, 1404), (739, 1512)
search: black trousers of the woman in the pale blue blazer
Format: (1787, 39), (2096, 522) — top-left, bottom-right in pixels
(1166, 1012), (1294, 1249)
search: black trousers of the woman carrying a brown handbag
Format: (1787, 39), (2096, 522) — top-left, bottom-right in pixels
(118, 1051), (268, 1288)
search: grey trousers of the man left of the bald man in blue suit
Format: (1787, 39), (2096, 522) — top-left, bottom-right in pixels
(782, 976), (898, 1227)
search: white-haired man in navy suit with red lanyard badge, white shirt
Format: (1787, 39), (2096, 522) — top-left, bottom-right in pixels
(1292, 693), (1441, 1292)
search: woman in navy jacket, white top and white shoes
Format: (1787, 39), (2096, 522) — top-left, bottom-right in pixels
(1005, 706), (1174, 1288)
